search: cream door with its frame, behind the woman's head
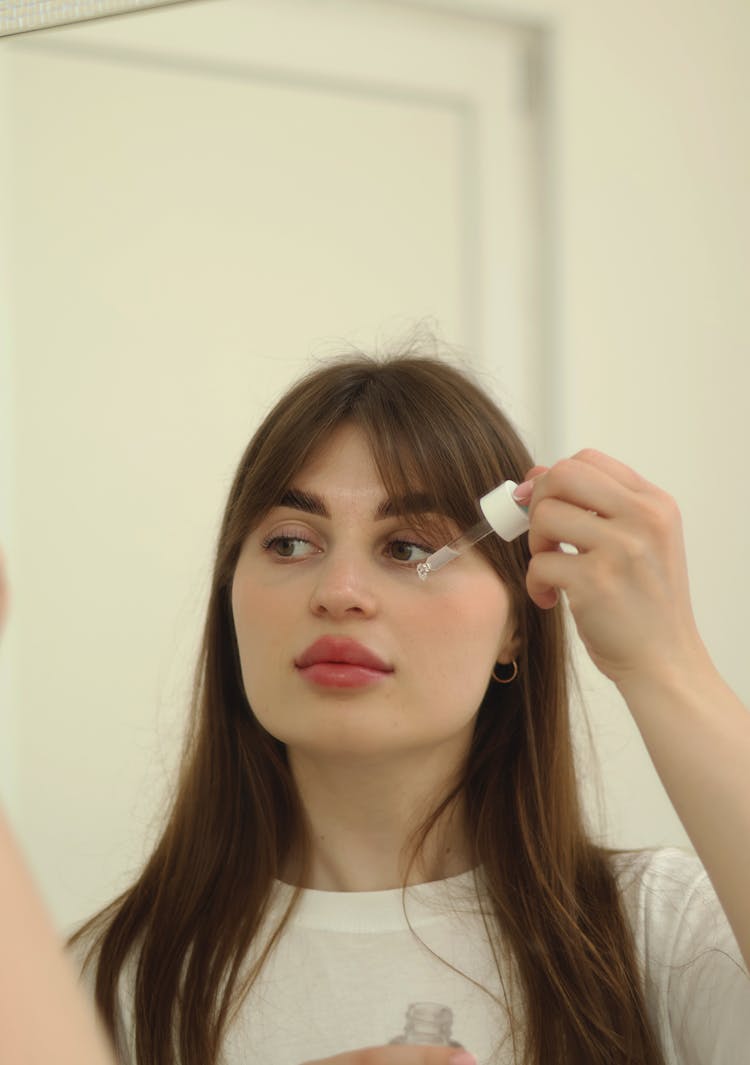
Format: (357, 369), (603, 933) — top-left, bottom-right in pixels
(0, 0), (547, 925)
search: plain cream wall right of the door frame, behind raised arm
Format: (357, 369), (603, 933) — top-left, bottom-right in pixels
(492, 0), (750, 845)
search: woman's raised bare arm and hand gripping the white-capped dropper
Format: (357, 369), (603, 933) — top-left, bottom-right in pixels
(517, 450), (750, 968)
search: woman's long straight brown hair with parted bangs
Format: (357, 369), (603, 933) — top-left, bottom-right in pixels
(74, 354), (663, 1065)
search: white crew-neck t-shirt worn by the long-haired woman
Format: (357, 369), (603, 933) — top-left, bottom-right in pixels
(107, 849), (750, 1065)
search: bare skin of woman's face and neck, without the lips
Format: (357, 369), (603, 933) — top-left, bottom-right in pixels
(232, 426), (513, 890)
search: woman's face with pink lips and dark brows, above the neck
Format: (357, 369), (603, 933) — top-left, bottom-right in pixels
(232, 425), (513, 761)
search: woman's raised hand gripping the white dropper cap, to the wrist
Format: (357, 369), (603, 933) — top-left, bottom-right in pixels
(521, 450), (707, 685)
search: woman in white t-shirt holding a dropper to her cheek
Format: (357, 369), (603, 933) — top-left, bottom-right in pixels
(5, 356), (750, 1065)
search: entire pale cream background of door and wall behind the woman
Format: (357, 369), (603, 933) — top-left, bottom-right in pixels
(0, 0), (750, 927)
